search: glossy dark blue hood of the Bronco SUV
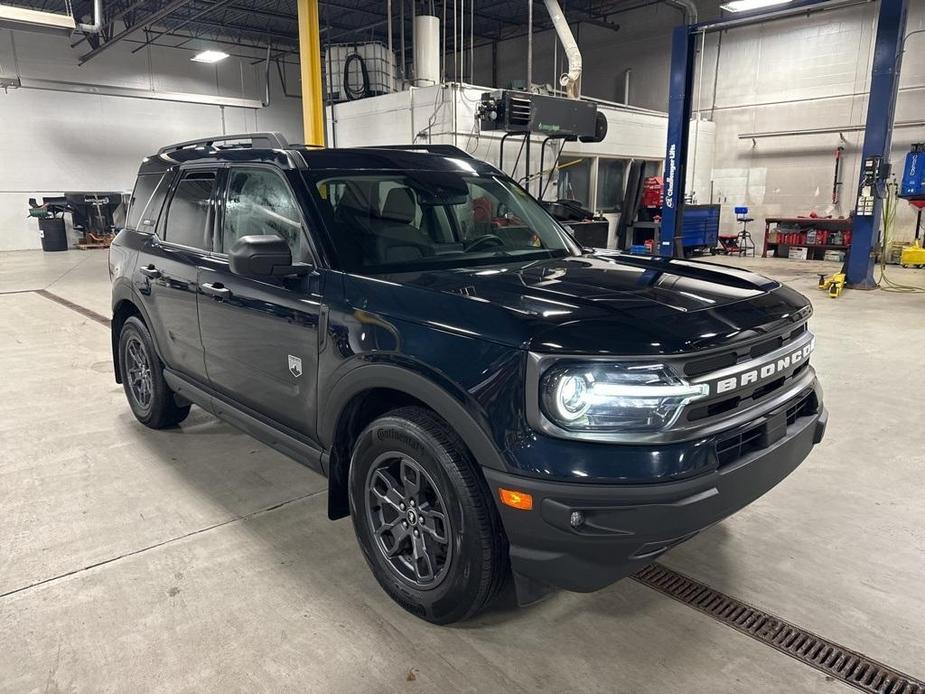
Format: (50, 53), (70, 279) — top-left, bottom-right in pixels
(347, 254), (810, 355)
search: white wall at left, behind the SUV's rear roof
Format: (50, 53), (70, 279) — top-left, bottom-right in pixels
(0, 30), (302, 250)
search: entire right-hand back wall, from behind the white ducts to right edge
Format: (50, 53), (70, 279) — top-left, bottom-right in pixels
(476, 0), (925, 243)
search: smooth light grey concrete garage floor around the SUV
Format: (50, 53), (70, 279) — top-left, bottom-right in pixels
(0, 251), (925, 694)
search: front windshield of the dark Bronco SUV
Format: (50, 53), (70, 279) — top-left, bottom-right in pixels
(314, 171), (576, 274)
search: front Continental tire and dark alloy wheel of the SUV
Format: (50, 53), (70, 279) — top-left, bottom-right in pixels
(349, 407), (509, 624)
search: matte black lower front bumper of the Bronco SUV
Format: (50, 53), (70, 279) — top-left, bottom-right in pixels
(484, 405), (828, 603)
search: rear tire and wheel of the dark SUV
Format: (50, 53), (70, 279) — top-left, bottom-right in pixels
(119, 316), (190, 429)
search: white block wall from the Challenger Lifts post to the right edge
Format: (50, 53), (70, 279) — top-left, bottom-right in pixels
(694, 2), (925, 239)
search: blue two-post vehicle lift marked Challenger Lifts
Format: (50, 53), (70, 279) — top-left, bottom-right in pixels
(658, 0), (908, 272)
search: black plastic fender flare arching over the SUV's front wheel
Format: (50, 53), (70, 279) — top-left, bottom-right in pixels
(318, 363), (508, 471)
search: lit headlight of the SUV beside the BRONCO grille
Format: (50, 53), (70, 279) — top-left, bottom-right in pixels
(540, 363), (708, 432)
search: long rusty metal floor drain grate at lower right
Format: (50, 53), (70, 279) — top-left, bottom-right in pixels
(633, 564), (925, 694)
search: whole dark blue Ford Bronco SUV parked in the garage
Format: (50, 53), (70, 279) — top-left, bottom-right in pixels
(110, 133), (826, 623)
